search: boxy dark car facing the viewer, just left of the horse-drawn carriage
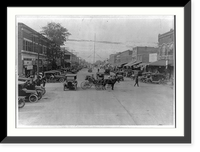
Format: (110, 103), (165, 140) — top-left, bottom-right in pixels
(63, 74), (78, 91)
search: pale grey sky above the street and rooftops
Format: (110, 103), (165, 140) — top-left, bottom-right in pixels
(17, 15), (174, 62)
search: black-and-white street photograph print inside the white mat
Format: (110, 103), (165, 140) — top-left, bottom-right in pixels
(15, 15), (176, 128)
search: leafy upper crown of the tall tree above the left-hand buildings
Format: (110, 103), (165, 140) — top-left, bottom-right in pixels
(41, 22), (71, 46)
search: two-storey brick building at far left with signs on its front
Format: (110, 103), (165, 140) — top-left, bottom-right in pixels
(17, 23), (52, 75)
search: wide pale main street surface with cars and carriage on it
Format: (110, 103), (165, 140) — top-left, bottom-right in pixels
(18, 69), (175, 127)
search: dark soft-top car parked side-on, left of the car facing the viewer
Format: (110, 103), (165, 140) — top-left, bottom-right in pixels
(44, 70), (65, 82)
